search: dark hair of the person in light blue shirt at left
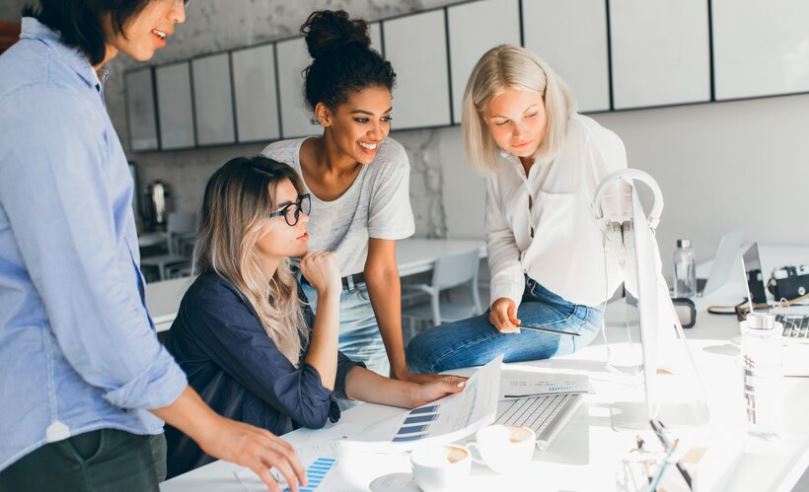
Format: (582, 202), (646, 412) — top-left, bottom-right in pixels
(22, 0), (149, 65)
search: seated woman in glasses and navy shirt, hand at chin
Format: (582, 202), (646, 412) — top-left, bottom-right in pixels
(166, 157), (464, 477)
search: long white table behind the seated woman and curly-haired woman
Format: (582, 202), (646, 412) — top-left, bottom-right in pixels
(146, 239), (486, 332)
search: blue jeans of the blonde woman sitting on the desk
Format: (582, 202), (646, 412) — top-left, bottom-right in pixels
(407, 277), (602, 372)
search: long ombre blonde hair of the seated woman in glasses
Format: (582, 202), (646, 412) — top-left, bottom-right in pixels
(194, 157), (309, 367)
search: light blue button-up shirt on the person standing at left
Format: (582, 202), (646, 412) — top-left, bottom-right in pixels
(0, 18), (187, 470)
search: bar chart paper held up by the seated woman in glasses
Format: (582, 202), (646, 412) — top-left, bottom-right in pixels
(343, 357), (503, 452)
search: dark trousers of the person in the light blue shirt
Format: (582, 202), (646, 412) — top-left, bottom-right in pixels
(0, 429), (166, 492)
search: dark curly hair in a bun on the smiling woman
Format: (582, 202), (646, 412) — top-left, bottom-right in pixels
(301, 10), (396, 109)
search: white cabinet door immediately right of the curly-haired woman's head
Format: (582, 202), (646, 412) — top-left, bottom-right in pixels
(382, 9), (452, 130)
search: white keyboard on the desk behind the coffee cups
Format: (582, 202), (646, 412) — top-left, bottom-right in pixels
(495, 393), (583, 449)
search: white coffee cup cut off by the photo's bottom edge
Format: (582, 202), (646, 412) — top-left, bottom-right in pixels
(410, 444), (472, 492)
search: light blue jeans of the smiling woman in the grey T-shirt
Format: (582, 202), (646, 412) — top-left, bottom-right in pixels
(301, 282), (390, 376)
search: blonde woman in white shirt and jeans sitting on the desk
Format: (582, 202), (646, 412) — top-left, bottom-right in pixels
(407, 45), (626, 372)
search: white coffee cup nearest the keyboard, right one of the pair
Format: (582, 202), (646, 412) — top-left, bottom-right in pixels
(467, 425), (537, 473)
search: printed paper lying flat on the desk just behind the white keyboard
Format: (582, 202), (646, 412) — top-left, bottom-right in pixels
(500, 369), (590, 398)
